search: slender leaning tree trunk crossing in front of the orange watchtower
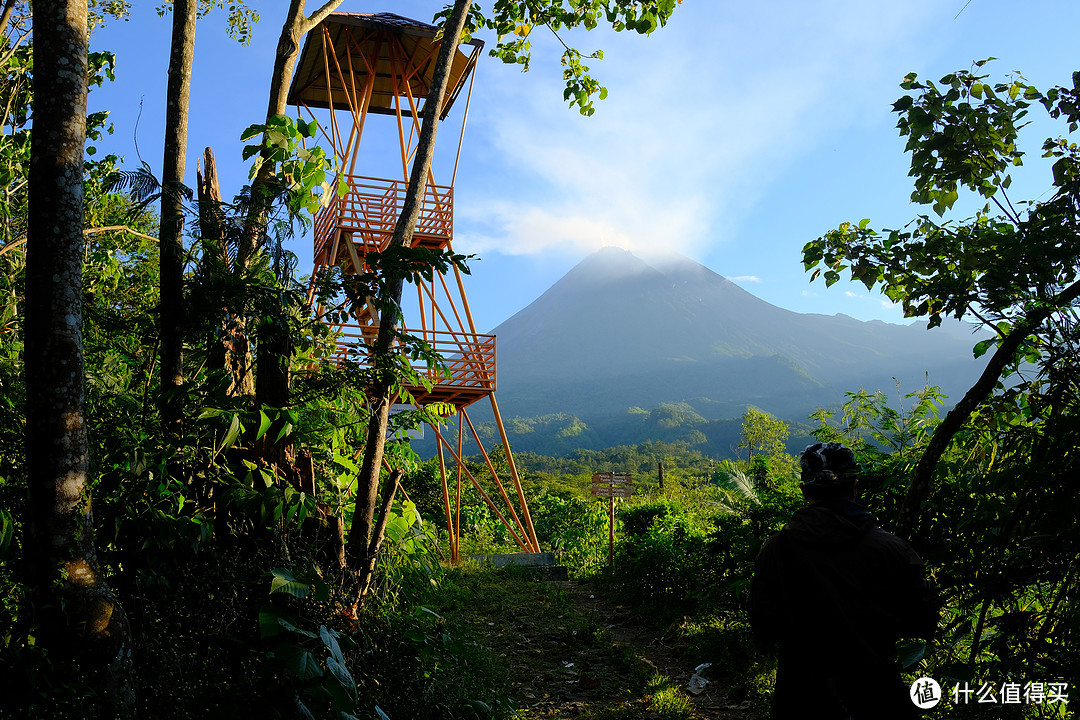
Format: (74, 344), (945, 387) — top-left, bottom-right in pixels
(346, 0), (472, 587)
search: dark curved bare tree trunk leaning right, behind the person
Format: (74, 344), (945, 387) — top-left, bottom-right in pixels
(895, 282), (1080, 540)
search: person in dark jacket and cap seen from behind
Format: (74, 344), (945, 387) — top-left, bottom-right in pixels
(751, 443), (937, 720)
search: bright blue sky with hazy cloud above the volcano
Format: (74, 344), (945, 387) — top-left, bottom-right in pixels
(91, 0), (1080, 331)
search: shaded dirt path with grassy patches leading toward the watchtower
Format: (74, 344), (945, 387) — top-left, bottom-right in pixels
(470, 569), (759, 720)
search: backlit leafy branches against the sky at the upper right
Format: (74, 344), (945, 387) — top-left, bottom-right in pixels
(804, 60), (1080, 332)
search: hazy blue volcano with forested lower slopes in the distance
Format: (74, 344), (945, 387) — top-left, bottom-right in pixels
(464, 247), (981, 453)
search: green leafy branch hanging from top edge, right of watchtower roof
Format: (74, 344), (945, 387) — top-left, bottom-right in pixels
(435, 0), (683, 116)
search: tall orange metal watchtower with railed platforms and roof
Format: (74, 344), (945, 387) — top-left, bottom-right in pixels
(288, 13), (539, 560)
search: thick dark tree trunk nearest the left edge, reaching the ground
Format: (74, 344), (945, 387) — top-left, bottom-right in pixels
(24, 0), (135, 717)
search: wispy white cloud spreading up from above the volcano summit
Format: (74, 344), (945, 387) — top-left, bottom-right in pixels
(459, 0), (929, 256)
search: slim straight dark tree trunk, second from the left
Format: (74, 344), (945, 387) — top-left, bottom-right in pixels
(159, 0), (198, 438)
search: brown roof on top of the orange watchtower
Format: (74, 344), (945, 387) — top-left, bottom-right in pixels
(288, 13), (484, 118)
